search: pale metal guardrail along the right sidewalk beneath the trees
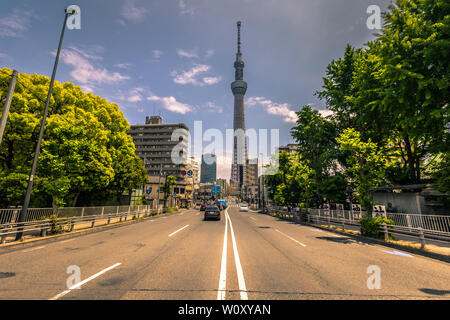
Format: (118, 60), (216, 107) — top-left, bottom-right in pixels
(268, 209), (450, 248)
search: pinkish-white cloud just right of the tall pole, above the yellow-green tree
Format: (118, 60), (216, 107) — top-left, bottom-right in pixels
(56, 47), (130, 90)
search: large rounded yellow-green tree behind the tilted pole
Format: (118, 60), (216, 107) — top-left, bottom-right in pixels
(0, 68), (146, 207)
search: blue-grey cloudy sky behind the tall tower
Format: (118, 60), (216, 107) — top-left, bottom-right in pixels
(0, 0), (390, 178)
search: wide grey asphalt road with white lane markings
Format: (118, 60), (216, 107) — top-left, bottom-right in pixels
(0, 205), (450, 300)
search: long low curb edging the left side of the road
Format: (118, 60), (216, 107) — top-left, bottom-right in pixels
(0, 209), (190, 255)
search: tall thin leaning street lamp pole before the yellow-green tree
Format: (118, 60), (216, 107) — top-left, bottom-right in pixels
(16, 8), (77, 241)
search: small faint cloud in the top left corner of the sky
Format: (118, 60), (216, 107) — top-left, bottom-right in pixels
(0, 9), (35, 38)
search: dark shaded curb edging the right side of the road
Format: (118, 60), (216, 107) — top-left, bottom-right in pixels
(270, 217), (450, 263)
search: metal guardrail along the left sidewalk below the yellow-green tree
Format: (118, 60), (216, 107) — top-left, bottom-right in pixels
(0, 206), (157, 244)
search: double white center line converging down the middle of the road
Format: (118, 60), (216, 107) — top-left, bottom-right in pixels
(217, 210), (248, 300)
